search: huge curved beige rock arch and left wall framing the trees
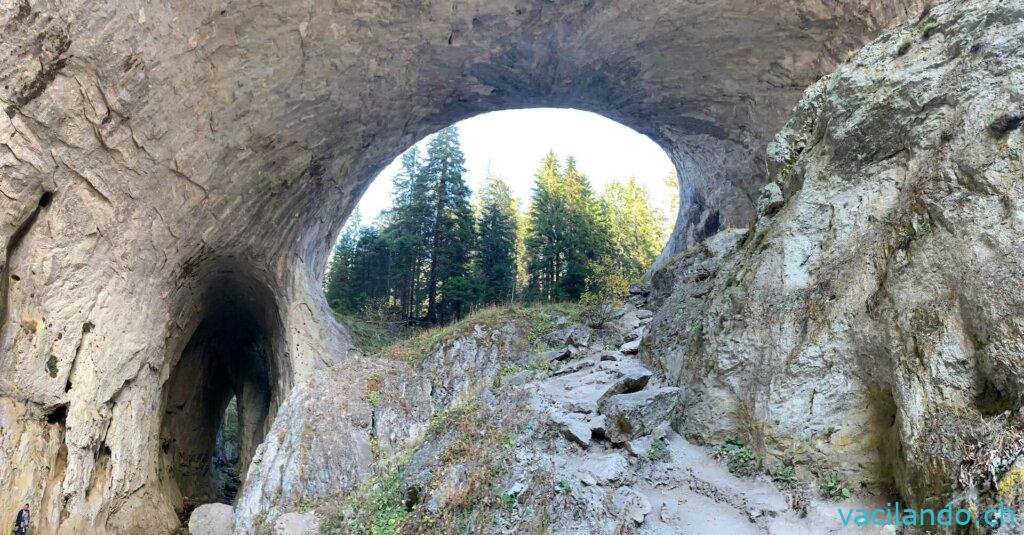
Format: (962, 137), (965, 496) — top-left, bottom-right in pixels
(0, 0), (929, 533)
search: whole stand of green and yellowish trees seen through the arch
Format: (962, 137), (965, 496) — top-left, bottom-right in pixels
(324, 137), (666, 327)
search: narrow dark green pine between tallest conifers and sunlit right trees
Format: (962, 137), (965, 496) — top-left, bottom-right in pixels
(474, 177), (518, 304)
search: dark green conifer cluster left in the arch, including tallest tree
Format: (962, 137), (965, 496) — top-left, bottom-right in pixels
(325, 126), (475, 324)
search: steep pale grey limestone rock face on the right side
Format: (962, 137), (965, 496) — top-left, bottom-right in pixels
(641, 0), (1024, 503)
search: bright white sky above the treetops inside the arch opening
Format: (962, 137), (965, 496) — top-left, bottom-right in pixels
(358, 108), (675, 224)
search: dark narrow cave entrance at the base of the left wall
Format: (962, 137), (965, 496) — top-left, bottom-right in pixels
(161, 274), (279, 518)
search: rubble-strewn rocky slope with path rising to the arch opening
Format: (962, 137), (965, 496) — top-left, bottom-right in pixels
(228, 292), (892, 533)
